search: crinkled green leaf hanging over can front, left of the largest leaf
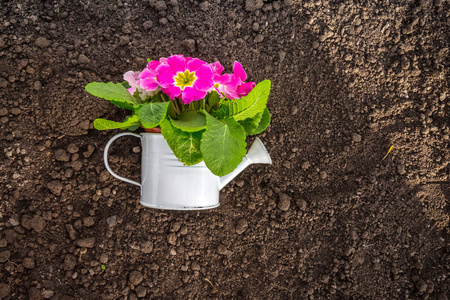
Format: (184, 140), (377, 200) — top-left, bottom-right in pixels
(160, 119), (203, 166)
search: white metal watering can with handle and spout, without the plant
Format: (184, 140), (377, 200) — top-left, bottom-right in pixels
(103, 132), (272, 210)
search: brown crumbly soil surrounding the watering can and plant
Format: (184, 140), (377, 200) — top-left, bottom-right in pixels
(0, 0), (450, 300)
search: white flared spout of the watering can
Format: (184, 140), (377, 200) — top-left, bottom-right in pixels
(219, 138), (272, 190)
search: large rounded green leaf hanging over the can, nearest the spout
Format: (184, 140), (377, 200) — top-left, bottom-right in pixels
(200, 112), (247, 176)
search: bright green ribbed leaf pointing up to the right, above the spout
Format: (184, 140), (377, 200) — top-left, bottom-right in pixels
(213, 80), (271, 121)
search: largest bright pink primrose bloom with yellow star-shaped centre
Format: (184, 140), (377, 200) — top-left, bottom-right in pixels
(156, 55), (214, 104)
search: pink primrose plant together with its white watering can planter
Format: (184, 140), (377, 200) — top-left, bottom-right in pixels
(86, 55), (271, 209)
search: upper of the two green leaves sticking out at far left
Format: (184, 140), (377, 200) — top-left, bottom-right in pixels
(85, 82), (140, 107)
